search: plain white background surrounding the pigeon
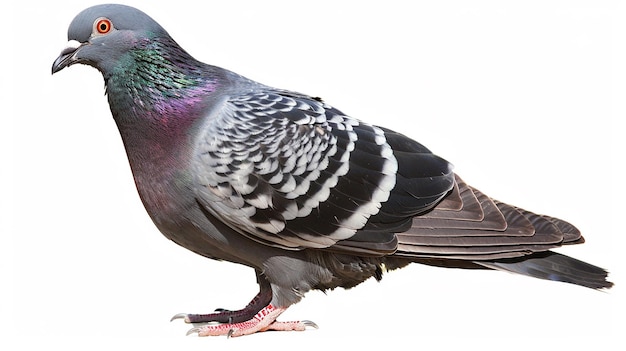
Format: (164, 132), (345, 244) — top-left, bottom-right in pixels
(0, 0), (626, 350)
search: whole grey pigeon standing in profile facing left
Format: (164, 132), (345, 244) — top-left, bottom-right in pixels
(52, 4), (613, 337)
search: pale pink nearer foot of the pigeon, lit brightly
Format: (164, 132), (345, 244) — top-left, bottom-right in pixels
(187, 304), (317, 337)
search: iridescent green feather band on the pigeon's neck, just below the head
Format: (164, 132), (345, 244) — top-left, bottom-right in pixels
(105, 38), (217, 120)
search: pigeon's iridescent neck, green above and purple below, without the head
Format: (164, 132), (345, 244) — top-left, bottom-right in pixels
(105, 37), (224, 155)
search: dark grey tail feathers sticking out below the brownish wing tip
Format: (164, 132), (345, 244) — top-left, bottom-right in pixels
(475, 251), (613, 289)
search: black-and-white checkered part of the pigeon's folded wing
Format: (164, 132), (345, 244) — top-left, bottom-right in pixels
(194, 90), (454, 254)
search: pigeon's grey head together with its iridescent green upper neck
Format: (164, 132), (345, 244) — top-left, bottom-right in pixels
(52, 4), (222, 121)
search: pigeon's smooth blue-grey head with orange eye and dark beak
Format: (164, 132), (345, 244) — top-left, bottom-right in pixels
(52, 4), (169, 77)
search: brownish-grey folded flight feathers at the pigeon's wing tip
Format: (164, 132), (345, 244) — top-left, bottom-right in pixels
(396, 176), (584, 262)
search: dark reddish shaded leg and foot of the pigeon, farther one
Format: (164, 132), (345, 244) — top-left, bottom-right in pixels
(171, 272), (272, 323)
